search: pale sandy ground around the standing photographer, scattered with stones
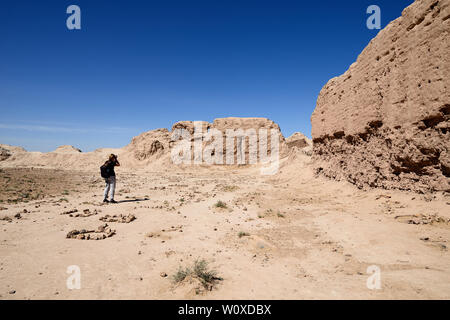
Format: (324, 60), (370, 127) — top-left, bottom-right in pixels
(0, 160), (450, 299)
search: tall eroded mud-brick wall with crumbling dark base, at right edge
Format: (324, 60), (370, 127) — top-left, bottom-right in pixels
(311, 0), (450, 191)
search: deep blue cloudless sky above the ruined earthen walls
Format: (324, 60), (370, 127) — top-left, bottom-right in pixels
(0, 0), (412, 151)
